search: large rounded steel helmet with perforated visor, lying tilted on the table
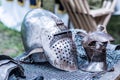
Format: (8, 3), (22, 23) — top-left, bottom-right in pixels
(21, 9), (78, 71)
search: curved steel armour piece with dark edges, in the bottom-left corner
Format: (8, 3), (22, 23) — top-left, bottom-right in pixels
(0, 55), (25, 80)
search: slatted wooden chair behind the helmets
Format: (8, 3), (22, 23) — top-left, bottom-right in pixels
(60, 0), (116, 32)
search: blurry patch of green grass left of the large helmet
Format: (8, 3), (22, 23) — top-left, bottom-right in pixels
(0, 23), (24, 57)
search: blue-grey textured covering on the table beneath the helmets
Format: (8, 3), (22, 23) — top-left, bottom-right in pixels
(14, 32), (120, 80)
